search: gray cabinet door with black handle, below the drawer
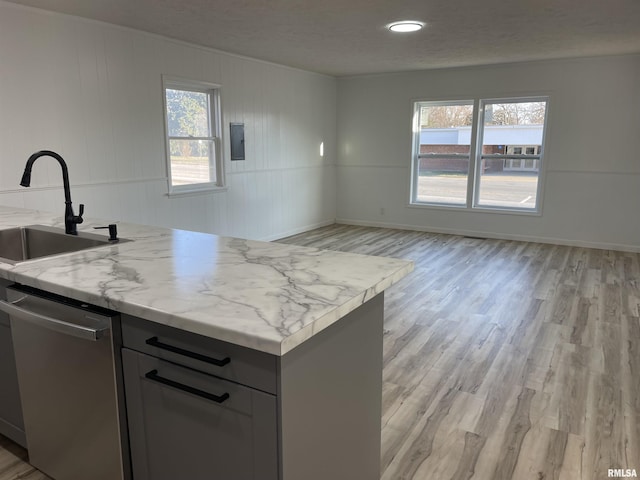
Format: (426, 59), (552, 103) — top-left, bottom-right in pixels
(122, 348), (278, 480)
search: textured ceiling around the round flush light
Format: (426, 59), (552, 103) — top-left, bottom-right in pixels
(5, 0), (640, 76)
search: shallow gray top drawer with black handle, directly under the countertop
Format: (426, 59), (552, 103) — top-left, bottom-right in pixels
(122, 315), (276, 394)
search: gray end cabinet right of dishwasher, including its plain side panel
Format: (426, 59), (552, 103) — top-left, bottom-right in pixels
(122, 294), (384, 480)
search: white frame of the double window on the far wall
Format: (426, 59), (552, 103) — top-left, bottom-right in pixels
(409, 95), (550, 216)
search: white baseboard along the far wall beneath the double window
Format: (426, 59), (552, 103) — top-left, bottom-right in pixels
(336, 218), (640, 253)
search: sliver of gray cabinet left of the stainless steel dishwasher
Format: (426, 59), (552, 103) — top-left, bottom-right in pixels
(0, 280), (27, 447)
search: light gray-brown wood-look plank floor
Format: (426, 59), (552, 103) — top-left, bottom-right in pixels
(0, 225), (640, 480)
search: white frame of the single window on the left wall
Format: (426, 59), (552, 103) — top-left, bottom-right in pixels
(162, 76), (226, 196)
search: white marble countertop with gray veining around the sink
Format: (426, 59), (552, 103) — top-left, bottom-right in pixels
(0, 205), (413, 355)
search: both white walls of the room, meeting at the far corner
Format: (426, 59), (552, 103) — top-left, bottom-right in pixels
(0, 0), (640, 250)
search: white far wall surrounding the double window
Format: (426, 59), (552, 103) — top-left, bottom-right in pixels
(337, 56), (640, 251)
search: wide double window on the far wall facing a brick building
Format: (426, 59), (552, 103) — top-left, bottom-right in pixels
(411, 97), (548, 212)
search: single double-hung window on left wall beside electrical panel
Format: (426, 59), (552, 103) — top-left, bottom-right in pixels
(164, 79), (224, 194)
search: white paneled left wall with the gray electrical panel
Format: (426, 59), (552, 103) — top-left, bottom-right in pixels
(0, 1), (336, 239)
